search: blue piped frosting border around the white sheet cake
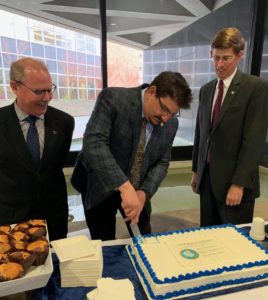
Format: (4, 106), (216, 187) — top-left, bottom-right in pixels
(127, 224), (268, 299)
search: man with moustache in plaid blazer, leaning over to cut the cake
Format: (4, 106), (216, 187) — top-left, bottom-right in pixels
(72, 72), (191, 240)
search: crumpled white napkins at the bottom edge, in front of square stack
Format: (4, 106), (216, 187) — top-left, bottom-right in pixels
(87, 277), (135, 300)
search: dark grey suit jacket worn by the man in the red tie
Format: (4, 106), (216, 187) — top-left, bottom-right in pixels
(192, 71), (268, 201)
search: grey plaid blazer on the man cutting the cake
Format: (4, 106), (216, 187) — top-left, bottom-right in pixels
(72, 86), (178, 209)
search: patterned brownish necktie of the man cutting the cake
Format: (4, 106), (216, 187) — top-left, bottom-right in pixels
(130, 118), (147, 190)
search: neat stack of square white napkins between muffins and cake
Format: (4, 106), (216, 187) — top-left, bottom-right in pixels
(51, 235), (103, 287)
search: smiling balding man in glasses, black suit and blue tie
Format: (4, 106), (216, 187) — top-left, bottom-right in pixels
(0, 58), (74, 240)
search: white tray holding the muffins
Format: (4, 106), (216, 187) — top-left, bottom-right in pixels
(0, 221), (53, 297)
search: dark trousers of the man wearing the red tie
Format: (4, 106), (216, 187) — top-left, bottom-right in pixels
(200, 164), (255, 226)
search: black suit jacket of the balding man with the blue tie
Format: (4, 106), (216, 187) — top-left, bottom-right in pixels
(0, 104), (74, 239)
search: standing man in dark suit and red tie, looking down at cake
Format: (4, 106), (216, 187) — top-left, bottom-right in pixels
(192, 28), (268, 226)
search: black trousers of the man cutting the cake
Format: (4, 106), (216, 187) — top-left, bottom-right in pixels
(82, 192), (151, 241)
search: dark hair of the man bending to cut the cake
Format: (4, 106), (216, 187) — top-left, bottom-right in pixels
(150, 71), (192, 108)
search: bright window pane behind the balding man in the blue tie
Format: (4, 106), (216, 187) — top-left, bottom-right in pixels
(0, 11), (102, 150)
